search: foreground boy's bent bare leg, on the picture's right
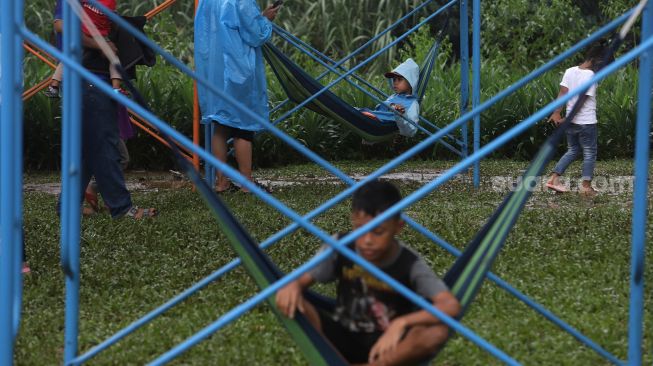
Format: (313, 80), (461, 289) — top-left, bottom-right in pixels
(371, 324), (449, 366)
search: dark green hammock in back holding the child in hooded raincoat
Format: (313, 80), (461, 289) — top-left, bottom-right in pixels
(263, 31), (444, 142)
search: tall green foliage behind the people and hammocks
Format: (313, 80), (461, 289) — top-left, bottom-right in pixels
(25, 0), (639, 169)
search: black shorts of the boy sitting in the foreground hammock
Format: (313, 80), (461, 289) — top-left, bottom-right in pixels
(319, 311), (383, 363)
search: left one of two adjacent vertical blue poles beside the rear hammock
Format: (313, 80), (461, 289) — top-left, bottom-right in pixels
(460, 0), (469, 157)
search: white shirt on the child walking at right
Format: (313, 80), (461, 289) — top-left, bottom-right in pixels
(560, 66), (597, 125)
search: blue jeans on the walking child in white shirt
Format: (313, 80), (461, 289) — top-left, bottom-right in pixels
(553, 123), (598, 180)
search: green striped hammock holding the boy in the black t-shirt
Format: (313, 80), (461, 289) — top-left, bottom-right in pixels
(162, 107), (582, 365)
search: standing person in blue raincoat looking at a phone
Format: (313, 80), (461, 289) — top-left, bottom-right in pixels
(195, 0), (279, 192)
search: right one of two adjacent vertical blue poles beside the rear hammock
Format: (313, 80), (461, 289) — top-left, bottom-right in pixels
(472, 0), (481, 188)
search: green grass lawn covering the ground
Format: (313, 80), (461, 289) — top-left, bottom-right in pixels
(15, 161), (653, 365)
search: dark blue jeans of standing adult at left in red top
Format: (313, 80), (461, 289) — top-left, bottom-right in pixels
(57, 81), (132, 218)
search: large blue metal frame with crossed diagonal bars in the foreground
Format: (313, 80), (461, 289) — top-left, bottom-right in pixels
(5, 0), (653, 365)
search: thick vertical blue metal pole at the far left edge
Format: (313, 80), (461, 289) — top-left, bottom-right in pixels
(0, 1), (22, 365)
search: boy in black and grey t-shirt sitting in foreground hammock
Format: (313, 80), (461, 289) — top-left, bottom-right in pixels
(276, 181), (460, 365)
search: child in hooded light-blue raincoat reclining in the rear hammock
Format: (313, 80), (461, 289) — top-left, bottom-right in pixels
(360, 58), (419, 137)
